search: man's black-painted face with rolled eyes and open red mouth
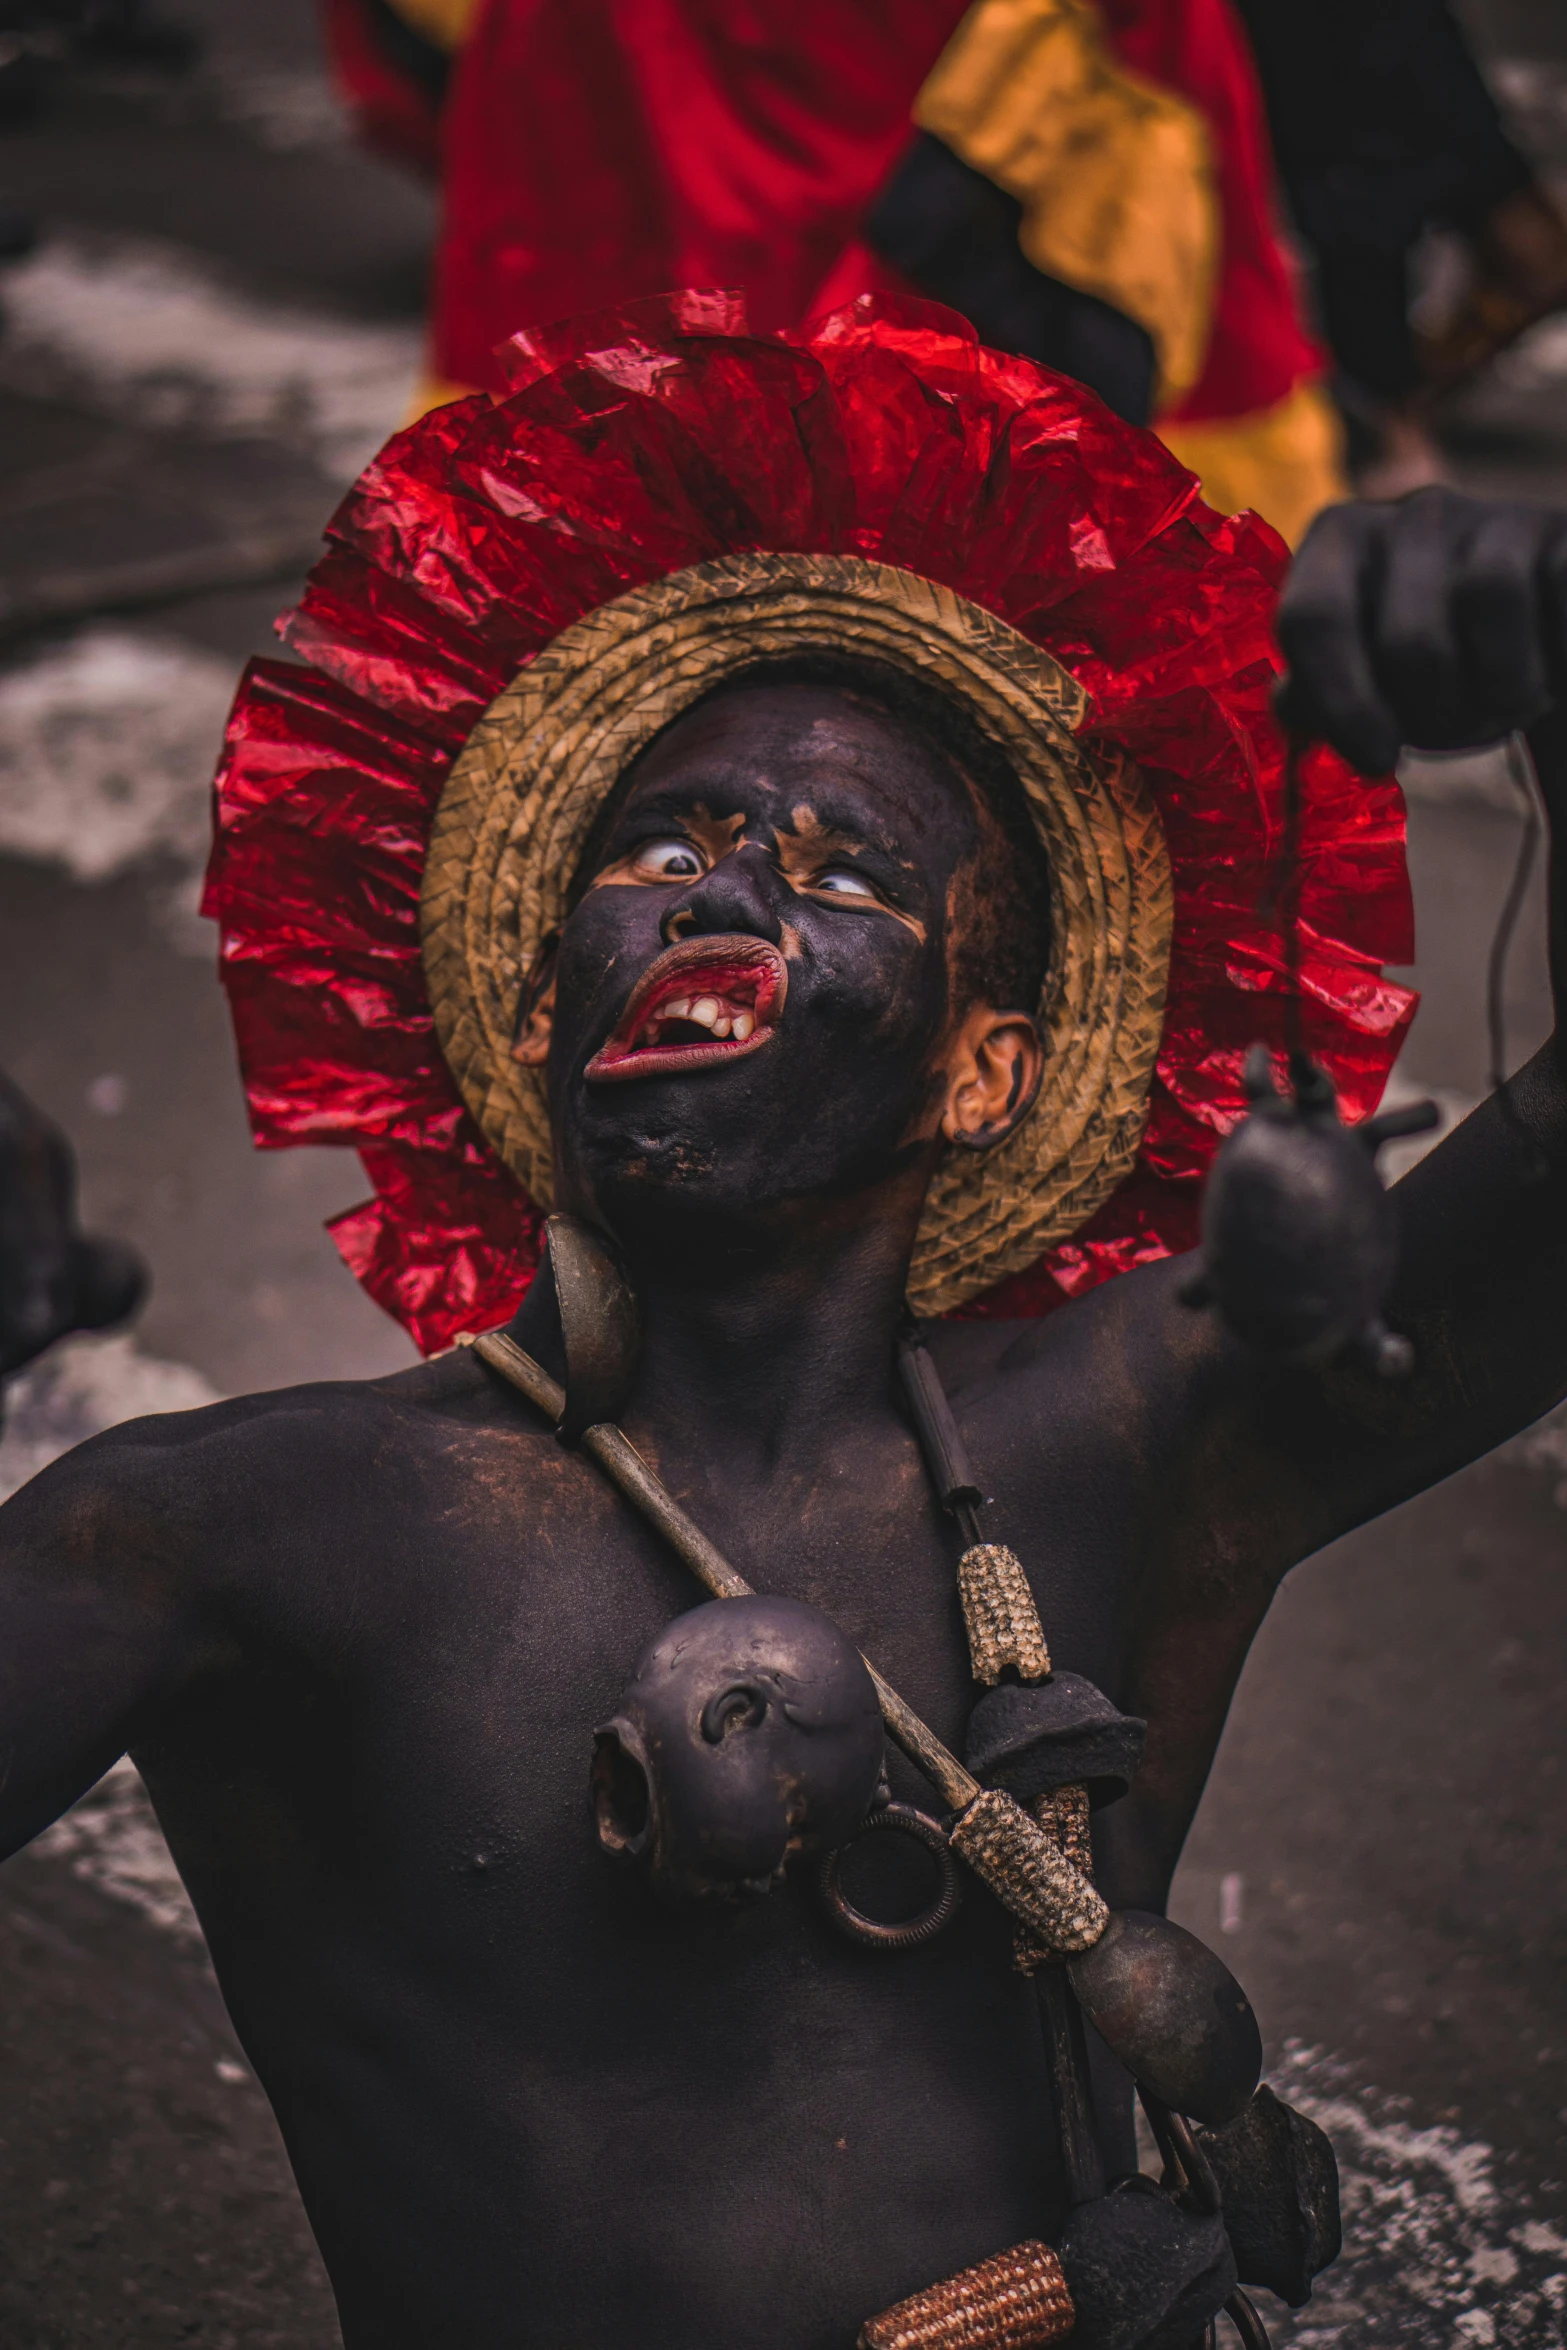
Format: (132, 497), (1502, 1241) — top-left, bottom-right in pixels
(522, 684), (977, 1224)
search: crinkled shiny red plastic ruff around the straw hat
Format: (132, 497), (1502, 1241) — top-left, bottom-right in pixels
(204, 294), (1414, 1349)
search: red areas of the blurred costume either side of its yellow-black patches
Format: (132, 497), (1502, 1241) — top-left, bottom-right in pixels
(429, 0), (1320, 418)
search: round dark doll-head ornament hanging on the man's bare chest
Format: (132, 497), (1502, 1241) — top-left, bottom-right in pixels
(592, 1598), (886, 1901)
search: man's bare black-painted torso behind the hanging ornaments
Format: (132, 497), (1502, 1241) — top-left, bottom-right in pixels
(107, 1297), (1165, 2350)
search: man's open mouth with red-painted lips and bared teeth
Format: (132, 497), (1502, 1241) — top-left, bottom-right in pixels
(583, 935), (789, 1083)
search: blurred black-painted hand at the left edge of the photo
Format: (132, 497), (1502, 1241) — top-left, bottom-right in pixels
(0, 1074), (148, 1379)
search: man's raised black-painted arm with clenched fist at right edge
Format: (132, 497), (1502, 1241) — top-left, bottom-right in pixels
(1269, 491), (1567, 1549)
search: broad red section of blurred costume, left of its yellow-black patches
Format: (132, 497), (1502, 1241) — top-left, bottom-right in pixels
(435, 0), (963, 376)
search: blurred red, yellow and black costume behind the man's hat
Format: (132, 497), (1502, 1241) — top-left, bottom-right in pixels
(327, 0), (1344, 538)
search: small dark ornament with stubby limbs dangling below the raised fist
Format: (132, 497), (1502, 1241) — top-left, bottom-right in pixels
(1182, 1043), (1440, 1377)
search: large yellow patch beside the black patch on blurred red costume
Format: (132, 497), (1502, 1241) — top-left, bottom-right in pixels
(914, 0), (1219, 407)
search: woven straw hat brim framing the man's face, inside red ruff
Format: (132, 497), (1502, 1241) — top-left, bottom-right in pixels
(423, 552), (1172, 1314)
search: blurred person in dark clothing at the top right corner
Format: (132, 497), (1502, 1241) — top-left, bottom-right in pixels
(1240, 0), (1567, 498)
